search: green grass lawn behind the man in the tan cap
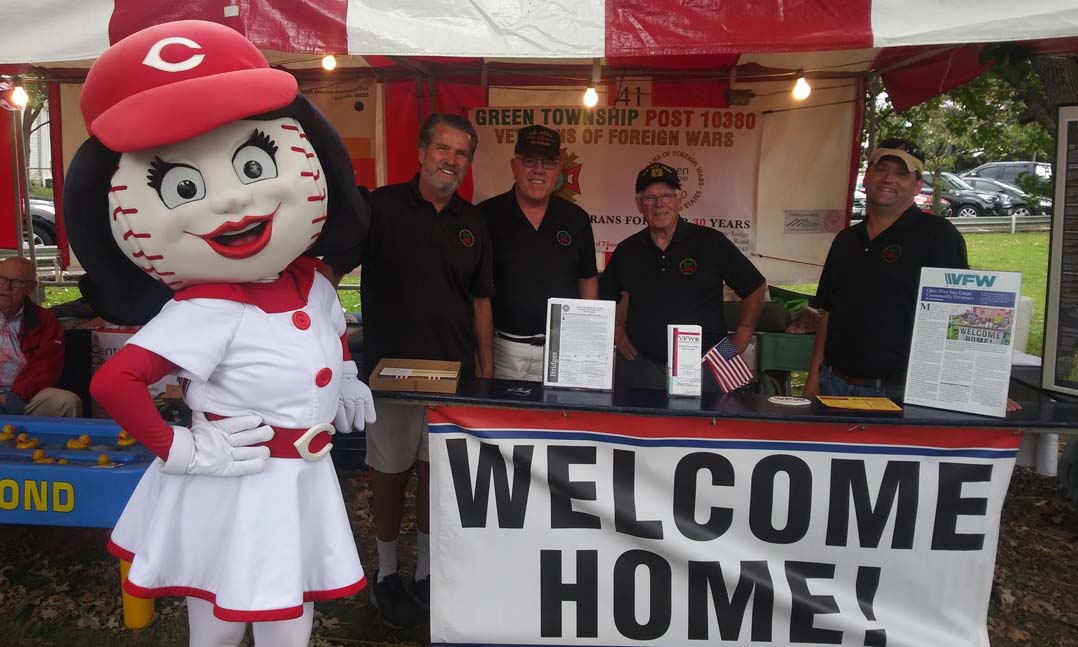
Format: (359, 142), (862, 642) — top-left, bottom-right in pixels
(782, 232), (1048, 357)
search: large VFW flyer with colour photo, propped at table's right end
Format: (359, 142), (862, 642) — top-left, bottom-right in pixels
(906, 267), (1022, 417)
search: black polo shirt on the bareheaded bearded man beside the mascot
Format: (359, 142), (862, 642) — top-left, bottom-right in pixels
(361, 176), (494, 374)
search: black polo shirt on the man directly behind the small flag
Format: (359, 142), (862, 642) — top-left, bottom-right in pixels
(599, 218), (764, 364)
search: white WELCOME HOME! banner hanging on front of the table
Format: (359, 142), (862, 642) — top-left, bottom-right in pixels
(430, 407), (1020, 647)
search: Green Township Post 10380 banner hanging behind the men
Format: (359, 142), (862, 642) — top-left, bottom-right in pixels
(469, 107), (762, 253)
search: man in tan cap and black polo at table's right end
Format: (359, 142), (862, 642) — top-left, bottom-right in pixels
(804, 138), (969, 402)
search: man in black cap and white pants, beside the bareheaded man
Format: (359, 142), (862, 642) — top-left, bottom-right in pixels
(479, 126), (598, 382)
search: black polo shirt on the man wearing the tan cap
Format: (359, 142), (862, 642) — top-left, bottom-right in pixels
(816, 207), (969, 377)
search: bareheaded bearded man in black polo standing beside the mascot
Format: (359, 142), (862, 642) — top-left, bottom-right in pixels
(327, 114), (493, 627)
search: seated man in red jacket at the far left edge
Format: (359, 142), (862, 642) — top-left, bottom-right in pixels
(0, 257), (82, 417)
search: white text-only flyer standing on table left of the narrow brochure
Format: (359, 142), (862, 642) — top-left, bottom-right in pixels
(542, 299), (616, 390)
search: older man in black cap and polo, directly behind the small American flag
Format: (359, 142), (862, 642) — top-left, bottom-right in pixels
(599, 163), (766, 391)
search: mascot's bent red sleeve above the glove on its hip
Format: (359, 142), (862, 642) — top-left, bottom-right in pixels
(89, 344), (176, 460)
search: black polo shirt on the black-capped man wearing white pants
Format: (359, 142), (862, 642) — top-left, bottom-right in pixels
(479, 188), (598, 335)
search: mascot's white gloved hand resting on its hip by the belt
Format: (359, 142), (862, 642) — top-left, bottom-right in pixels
(161, 411), (274, 477)
